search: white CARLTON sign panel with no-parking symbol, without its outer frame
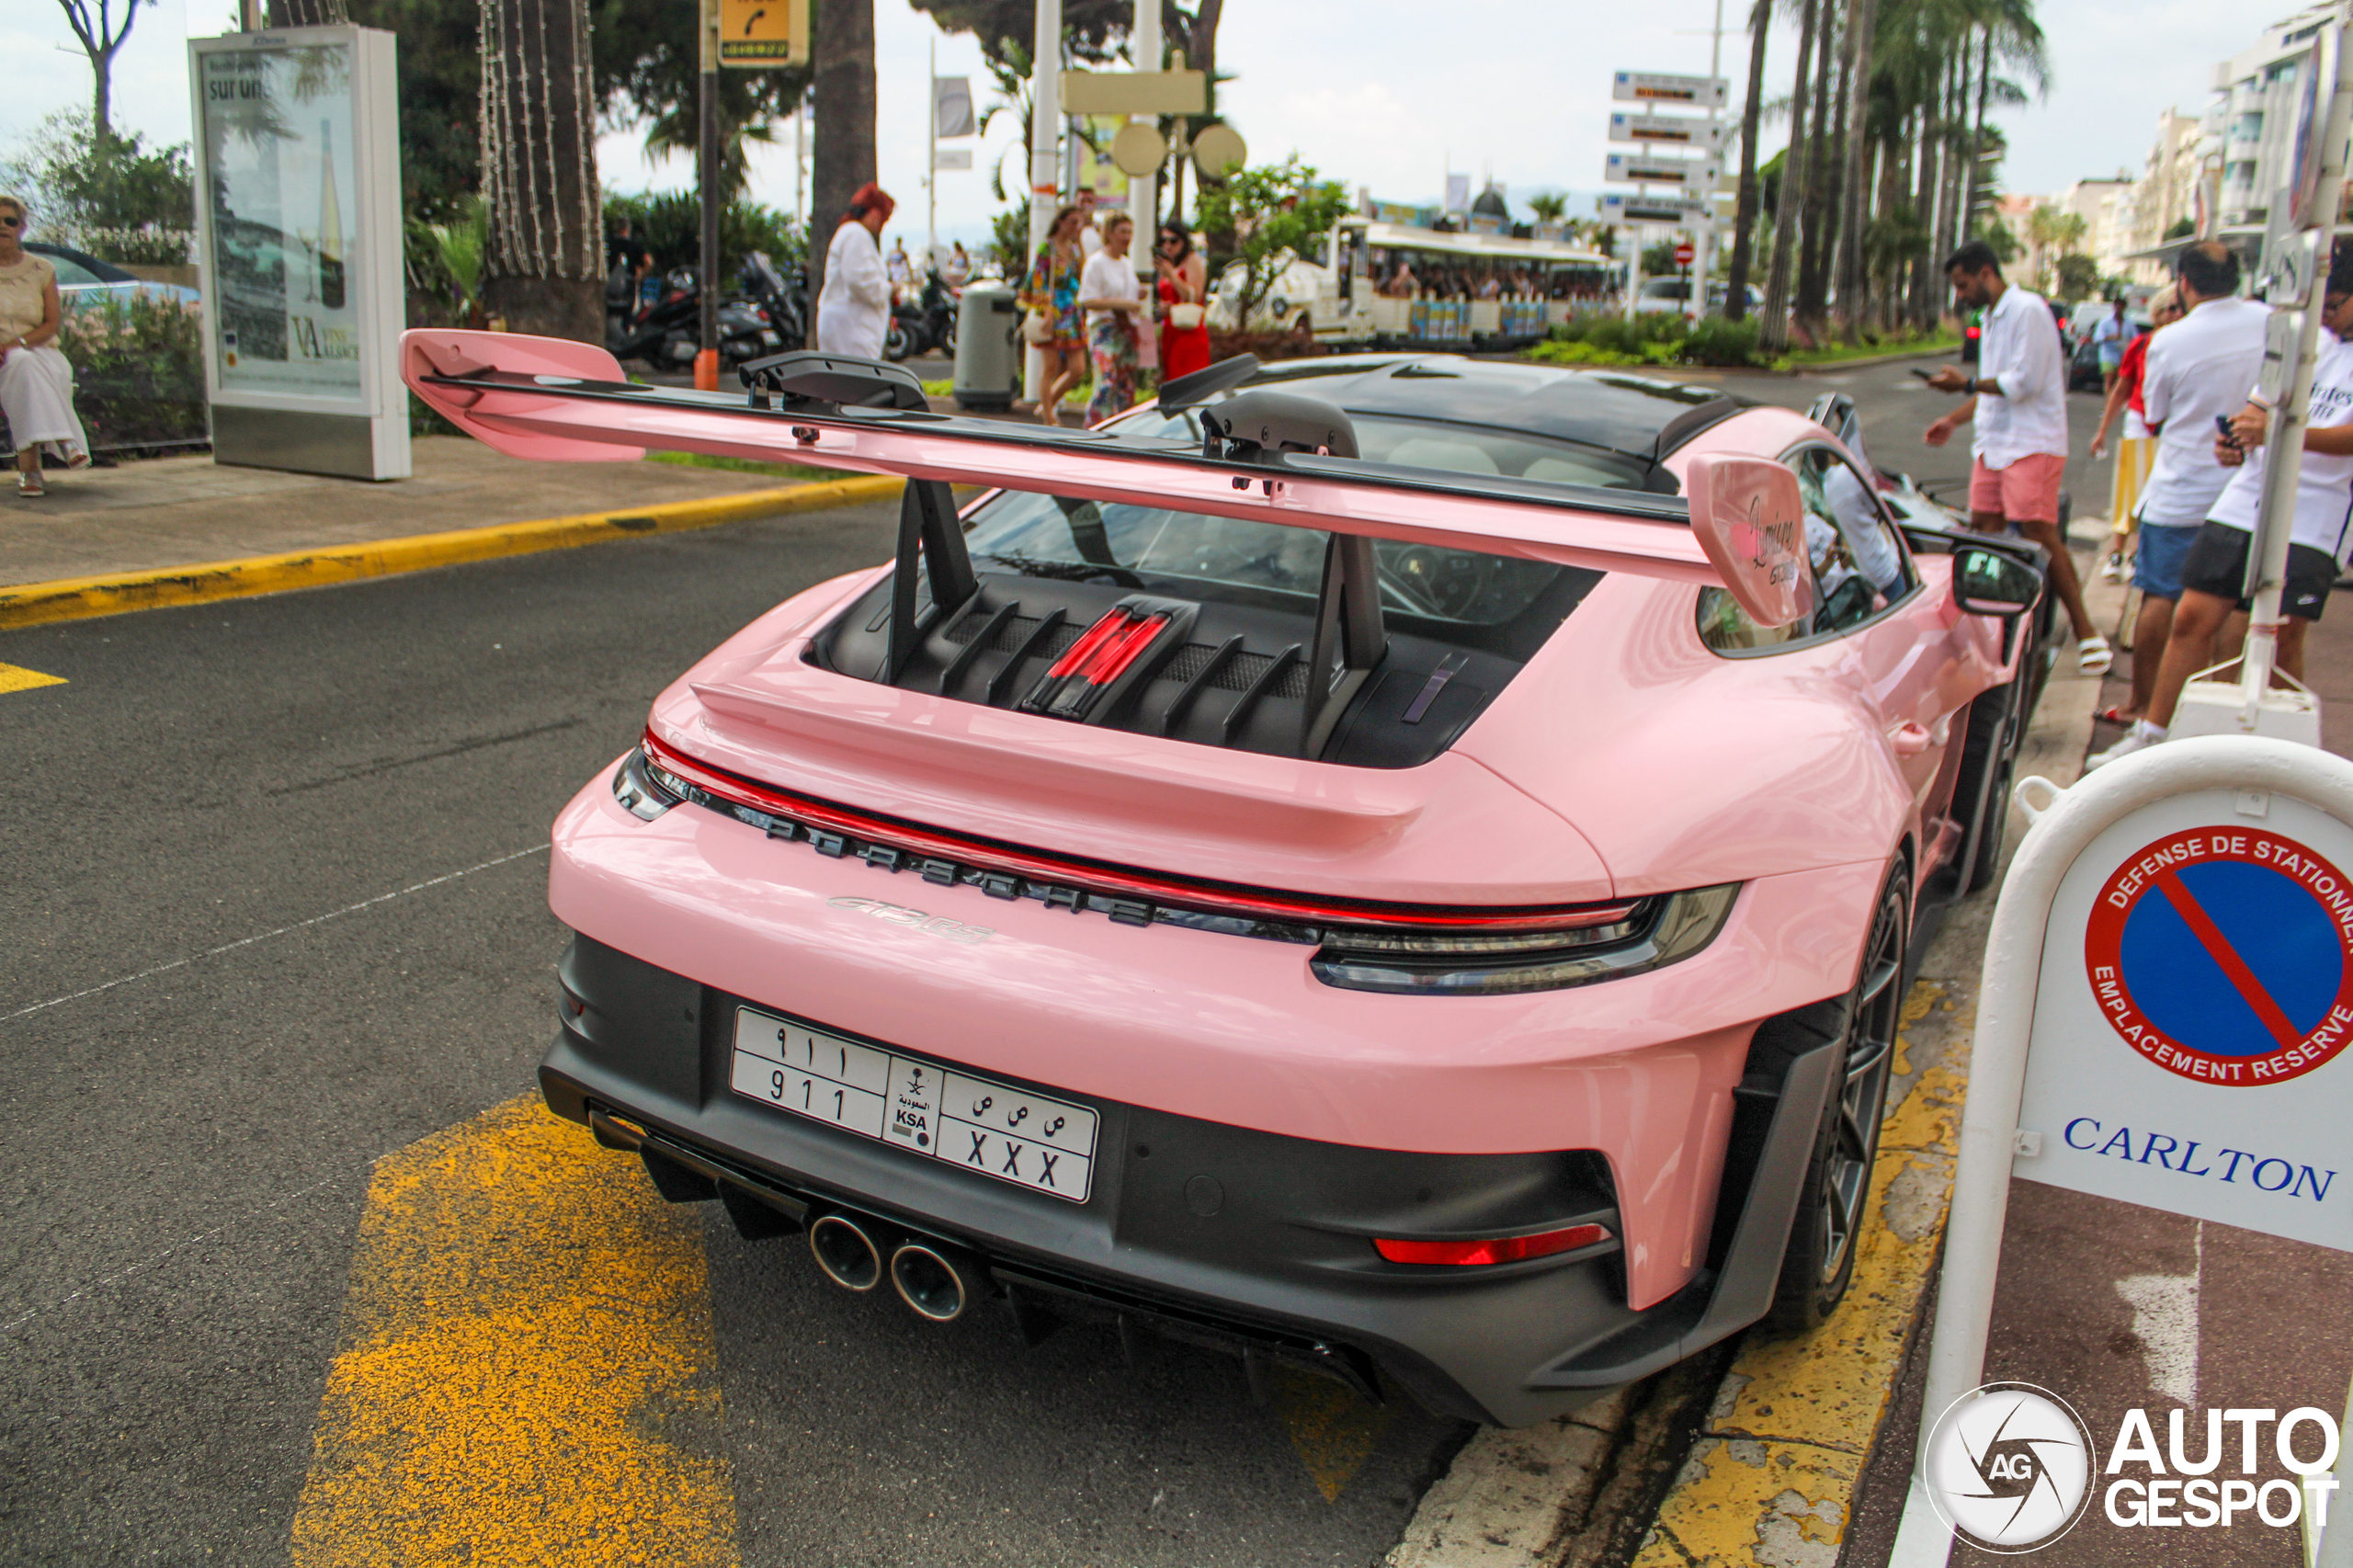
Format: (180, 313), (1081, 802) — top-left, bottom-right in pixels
(2012, 786), (2353, 1250)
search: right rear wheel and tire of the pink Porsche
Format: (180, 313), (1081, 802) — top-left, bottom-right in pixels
(1751, 867), (1911, 1335)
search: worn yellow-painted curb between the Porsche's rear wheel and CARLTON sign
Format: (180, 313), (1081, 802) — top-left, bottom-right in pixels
(1633, 980), (1974, 1568)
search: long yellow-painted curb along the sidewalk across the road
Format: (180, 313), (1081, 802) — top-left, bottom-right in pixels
(0, 475), (906, 631)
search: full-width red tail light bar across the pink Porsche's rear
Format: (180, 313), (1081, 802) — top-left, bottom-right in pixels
(642, 724), (1643, 932)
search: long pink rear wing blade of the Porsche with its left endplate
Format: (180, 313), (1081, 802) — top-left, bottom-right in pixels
(403, 330), (1722, 584)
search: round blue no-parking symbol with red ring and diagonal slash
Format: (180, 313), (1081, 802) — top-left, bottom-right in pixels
(2083, 826), (2353, 1087)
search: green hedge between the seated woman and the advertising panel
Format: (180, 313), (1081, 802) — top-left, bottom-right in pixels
(56, 294), (211, 452)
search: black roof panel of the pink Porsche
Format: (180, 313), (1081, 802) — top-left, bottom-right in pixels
(1247, 353), (1751, 464)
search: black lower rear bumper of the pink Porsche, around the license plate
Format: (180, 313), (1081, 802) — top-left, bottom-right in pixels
(539, 937), (1833, 1426)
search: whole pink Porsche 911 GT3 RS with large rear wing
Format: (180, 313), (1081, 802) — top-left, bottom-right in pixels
(403, 332), (2045, 1425)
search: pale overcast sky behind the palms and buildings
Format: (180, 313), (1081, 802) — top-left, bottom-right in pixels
(0, 0), (2294, 250)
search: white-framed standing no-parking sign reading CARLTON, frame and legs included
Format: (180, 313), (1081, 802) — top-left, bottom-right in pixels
(1890, 737), (2353, 1568)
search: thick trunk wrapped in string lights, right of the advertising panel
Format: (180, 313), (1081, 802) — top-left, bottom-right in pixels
(483, 0), (605, 344)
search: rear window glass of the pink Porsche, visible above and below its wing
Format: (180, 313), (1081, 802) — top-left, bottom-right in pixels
(965, 410), (1643, 626)
